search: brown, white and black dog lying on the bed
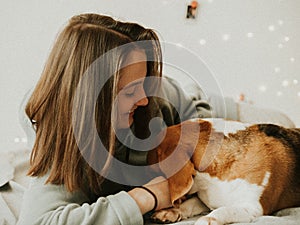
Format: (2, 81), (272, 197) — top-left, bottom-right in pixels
(149, 120), (300, 225)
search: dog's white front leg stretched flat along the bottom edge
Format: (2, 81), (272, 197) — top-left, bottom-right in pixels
(195, 204), (263, 225)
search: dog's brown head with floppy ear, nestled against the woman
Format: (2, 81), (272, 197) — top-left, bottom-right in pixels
(148, 120), (212, 205)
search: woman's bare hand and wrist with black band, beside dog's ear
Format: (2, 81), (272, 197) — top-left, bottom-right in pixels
(128, 177), (172, 214)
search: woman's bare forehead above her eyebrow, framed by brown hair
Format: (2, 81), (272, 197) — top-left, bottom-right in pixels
(118, 50), (147, 89)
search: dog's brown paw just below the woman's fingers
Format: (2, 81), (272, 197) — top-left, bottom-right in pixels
(151, 208), (182, 223)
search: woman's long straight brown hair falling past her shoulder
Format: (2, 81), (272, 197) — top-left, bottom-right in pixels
(25, 14), (161, 193)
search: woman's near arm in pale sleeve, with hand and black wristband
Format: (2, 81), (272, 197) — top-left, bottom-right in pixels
(17, 176), (171, 225)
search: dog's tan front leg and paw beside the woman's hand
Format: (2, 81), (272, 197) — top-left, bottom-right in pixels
(151, 197), (210, 223)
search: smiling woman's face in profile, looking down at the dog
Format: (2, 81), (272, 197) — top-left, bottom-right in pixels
(115, 50), (148, 129)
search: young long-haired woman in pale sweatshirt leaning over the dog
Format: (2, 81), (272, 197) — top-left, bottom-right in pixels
(18, 14), (230, 225)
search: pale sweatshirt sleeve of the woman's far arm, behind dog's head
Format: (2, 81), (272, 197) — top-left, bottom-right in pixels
(161, 77), (238, 125)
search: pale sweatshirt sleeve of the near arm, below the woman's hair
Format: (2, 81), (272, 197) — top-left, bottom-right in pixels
(17, 177), (143, 225)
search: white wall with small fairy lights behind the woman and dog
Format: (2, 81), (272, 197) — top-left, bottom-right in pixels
(0, 0), (300, 151)
